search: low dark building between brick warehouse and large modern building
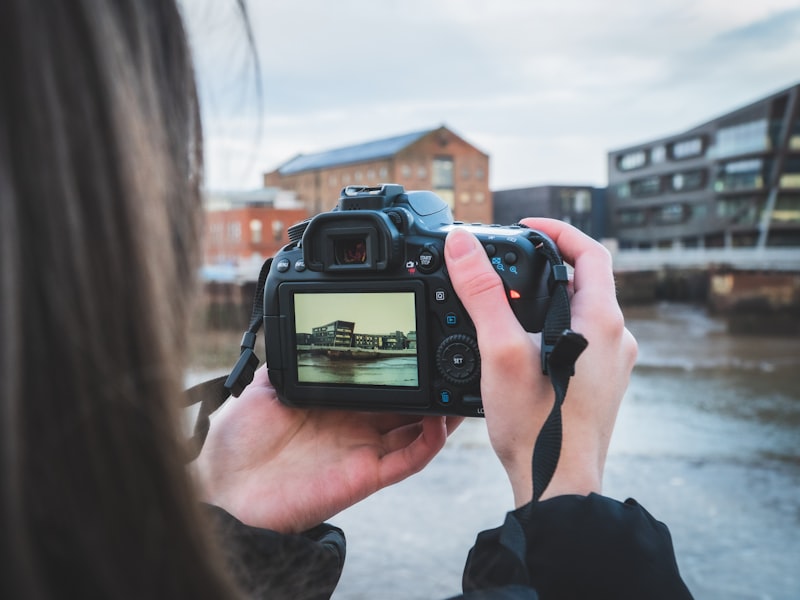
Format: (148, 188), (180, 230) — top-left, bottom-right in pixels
(492, 185), (608, 240)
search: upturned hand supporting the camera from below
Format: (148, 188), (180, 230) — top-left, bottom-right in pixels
(193, 367), (461, 533)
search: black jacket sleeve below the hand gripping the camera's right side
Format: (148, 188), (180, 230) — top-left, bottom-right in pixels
(463, 494), (692, 600)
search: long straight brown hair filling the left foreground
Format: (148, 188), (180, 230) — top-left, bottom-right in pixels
(0, 0), (241, 598)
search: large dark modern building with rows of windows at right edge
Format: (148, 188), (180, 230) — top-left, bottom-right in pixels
(608, 84), (800, 248)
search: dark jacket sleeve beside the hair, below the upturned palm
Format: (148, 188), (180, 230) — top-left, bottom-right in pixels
(205, 505), (345, 600)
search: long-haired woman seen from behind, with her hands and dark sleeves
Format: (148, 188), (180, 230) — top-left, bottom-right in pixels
(0, 0), (688, 598)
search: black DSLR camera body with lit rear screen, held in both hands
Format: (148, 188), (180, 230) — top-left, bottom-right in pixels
(264, 184), (560, 416)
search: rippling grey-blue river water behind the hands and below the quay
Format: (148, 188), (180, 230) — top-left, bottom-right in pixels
(331, 304), (800, 600)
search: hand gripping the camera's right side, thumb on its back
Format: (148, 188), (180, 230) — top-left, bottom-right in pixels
(445, 219), (637, 507)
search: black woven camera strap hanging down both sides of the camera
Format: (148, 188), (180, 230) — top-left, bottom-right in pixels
(185, 238), (588, 502)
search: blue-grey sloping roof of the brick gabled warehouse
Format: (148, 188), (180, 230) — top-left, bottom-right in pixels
(278, 129), (436, 175)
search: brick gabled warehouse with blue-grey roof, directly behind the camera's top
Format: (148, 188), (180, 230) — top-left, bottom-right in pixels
(264, 126), (492, 223)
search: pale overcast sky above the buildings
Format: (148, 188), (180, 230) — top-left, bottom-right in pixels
(182, 0), (800, 190)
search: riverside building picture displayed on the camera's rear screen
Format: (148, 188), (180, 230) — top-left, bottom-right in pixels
(294, 292), (419, 387)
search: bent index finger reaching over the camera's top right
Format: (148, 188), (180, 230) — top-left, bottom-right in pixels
(521, 217), (617, 298)
